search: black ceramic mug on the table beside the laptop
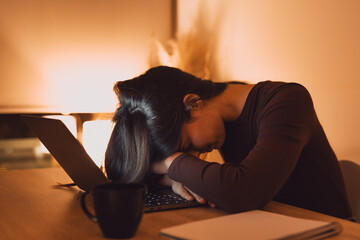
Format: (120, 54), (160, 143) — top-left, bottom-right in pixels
(81, 183), (145, 238)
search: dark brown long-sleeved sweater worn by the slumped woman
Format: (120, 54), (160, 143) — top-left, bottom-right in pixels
(169, 81), (351, 218)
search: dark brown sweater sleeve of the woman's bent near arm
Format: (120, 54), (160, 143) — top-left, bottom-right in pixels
(168, 84), (315, 212)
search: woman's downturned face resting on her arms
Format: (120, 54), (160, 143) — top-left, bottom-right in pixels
(181, 105), (225, 153)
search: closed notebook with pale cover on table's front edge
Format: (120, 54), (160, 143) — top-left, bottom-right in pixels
(160, 210), (341, 240)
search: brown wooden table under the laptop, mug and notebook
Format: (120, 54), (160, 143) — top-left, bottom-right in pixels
(0, 168), (360, 240)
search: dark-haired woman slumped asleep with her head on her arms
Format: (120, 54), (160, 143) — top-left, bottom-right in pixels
(105, 66), (351, 218)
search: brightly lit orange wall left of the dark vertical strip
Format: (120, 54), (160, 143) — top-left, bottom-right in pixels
(0, 0), (171, 112)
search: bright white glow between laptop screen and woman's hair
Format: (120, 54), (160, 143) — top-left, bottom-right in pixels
(83, 120), (113, 167)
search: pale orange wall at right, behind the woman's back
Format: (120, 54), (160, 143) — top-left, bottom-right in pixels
(178, 0), (360, 164)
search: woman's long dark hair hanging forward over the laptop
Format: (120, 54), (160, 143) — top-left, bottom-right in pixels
(105, 66), (227, 183)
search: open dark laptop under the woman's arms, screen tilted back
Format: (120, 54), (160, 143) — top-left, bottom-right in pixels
(22, 115), (200, 212)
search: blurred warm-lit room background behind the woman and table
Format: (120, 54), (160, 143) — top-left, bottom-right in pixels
(0, 0), (360, 170)
